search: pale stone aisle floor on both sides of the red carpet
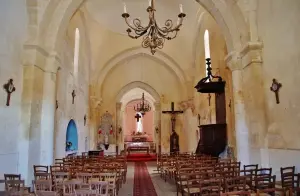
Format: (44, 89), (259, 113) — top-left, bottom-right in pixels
(119, 162), (176, 196)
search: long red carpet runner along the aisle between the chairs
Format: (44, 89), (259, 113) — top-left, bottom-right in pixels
(133, 162), (157, 196)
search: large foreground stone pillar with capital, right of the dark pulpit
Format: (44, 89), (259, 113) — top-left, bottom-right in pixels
(226, 42), (266, 164)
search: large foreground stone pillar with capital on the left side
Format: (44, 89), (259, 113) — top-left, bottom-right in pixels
(19, 48), (60, 183)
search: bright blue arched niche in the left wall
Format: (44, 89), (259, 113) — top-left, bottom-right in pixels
(66, 119), (78, 154)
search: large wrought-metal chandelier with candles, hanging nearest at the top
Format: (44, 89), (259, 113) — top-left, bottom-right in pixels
(122, 0), (186, 55)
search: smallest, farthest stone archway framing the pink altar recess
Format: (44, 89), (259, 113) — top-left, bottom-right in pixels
(115, 81), (161, 153)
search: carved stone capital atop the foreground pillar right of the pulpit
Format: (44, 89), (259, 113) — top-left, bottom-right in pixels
(225, 42), (263, 71)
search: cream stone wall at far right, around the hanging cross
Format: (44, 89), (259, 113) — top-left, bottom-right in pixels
(257, 0), (300, 171)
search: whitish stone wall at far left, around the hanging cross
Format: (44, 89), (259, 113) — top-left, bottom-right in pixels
(0, 0), (27, 181)
